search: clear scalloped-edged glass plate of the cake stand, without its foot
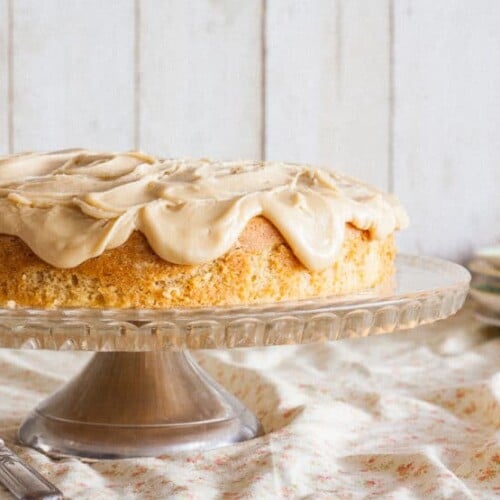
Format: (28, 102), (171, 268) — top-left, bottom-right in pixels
(0, 255), (470, 351)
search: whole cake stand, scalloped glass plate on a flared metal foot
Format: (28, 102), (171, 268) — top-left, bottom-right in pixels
(0, 255), (470, 459)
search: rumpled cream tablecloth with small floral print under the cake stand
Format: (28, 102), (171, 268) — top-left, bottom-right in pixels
(0, 310), (500, 499)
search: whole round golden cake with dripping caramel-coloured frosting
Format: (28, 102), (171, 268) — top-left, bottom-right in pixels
(0, 149), (407, 308)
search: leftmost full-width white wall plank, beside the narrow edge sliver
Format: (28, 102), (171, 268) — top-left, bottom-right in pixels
(13, 0), (134, 151)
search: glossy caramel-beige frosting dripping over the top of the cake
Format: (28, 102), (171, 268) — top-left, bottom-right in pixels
(0, 150), (408, 270)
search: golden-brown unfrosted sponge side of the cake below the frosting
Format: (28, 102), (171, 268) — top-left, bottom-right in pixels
(0, 216), (395, 308)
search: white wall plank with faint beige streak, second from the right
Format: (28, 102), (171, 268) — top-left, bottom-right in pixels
(266, 0), (390, 188)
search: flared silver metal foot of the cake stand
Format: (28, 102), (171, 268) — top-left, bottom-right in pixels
(19, 351), (262, 459)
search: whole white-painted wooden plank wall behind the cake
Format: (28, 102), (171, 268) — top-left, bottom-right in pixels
(0, 0), (500, 260)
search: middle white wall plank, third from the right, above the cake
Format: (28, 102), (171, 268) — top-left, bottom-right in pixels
(139, 0), (262, 158)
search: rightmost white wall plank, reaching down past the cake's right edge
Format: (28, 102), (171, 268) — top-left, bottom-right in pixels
(394, 0), (500, 260)
